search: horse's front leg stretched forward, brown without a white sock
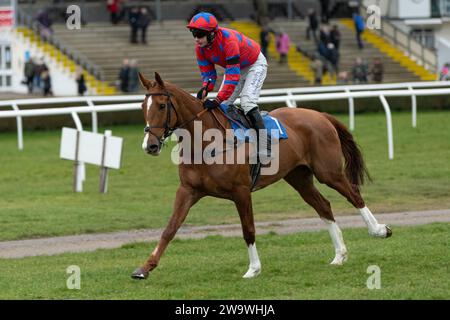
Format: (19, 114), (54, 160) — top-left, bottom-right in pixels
(131, 186), (201, 279)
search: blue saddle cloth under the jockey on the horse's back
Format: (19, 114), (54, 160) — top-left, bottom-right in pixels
(220, 104), (288, 142)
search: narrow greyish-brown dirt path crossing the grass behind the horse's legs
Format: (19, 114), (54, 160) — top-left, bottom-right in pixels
(0, 209), (450, 258)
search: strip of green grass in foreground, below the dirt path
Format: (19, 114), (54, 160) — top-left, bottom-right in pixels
(0, 223), (450, 299)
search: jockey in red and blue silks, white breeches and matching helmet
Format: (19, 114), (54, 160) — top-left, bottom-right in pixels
(187, 12), (267, 156)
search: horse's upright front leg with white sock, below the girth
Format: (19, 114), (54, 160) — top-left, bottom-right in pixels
(233, 187), (261, 278)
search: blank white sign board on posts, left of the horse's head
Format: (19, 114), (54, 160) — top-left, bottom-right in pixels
(60, 128), (123, 169)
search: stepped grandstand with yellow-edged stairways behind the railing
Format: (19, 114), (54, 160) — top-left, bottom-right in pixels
(2, 0), (446, 94)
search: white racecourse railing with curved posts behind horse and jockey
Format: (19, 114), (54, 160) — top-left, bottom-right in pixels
(0, 82), (450, 159)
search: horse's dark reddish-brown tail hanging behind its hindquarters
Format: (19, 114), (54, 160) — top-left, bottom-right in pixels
(323, 113), (371, 189)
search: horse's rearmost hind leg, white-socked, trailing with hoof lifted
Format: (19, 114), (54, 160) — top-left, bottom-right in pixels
(318, 173), (392, 238)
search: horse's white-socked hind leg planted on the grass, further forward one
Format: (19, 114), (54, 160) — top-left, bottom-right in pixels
(284, 166), (347, 265)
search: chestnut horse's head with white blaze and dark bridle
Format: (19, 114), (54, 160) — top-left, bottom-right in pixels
(139, 72), (178, 156)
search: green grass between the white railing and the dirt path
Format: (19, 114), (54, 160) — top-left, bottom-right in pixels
(0, 112), (450, 240)
